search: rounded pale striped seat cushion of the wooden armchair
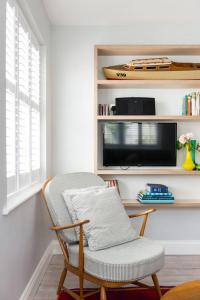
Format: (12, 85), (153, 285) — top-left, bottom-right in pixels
(69, 237), (164, 281)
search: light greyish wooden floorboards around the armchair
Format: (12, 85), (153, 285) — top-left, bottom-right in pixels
(32, 255), (200, 300)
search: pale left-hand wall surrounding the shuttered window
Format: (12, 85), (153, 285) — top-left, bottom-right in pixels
(0, 0), (52, 300)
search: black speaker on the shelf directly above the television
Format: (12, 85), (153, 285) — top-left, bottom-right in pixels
(115, 97), (156, 115)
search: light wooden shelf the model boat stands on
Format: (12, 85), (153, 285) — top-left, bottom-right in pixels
(97, 79), (200, 89)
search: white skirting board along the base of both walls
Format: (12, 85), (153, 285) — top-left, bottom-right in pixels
(19, 240), (200, 300)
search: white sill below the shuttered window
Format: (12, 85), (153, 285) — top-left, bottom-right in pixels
(2, 182), (42, 216)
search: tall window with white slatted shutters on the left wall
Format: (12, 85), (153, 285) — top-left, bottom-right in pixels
(6, 0), (41, 197)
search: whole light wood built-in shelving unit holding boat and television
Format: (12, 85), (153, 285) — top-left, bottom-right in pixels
(94, 45), (200, 208)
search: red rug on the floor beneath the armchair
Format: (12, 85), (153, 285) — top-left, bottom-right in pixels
(58, 287), (171, 300)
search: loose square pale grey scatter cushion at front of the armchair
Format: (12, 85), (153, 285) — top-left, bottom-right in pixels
(63, 187), (137, 250)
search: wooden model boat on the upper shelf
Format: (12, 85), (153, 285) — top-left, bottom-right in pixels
(103, 57), (200, 80)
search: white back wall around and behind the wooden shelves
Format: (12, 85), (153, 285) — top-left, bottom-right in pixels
(51, 23), (200, 240)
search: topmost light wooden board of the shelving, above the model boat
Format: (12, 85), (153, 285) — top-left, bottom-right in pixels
(95, 45), (200, 56)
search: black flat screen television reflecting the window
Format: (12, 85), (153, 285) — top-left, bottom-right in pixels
(103, 121), (177, 167)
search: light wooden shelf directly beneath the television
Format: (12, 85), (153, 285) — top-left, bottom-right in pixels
(96, 167), (200, 176)
